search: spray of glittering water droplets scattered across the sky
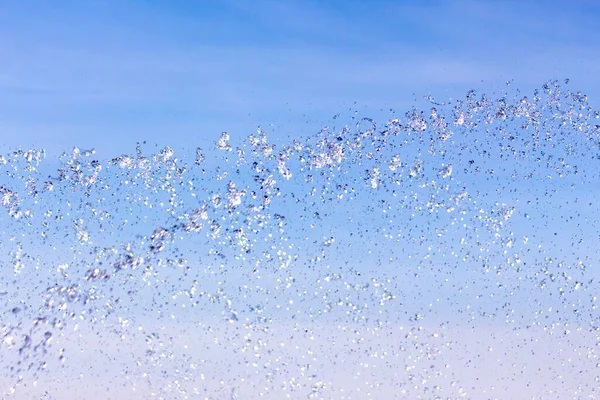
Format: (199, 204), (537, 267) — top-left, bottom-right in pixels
(0, 81), (600, 399)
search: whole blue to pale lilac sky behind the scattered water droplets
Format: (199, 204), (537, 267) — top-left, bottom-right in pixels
(0, 0), (600, 399)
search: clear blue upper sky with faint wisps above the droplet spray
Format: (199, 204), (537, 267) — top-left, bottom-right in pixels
(0, 1), (600, 157)
